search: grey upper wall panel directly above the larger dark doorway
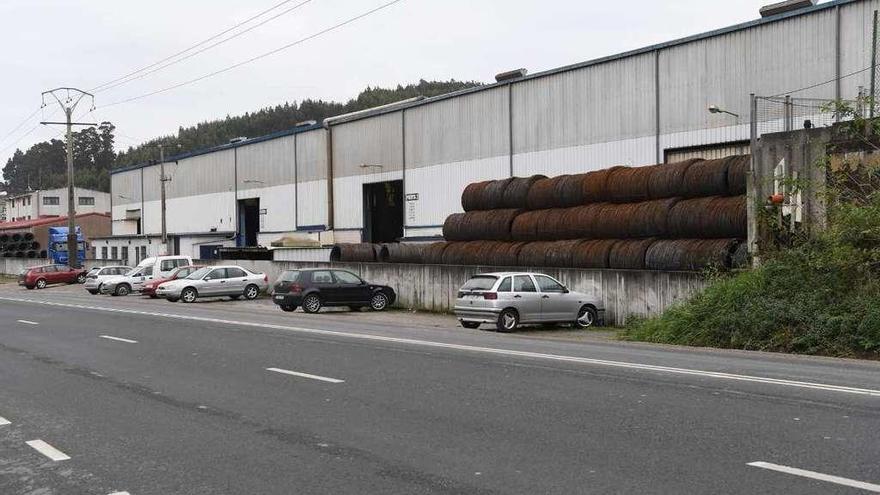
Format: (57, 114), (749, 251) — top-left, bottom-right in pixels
(331, 112), (403, 179)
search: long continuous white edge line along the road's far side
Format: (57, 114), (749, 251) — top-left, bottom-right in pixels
(0, 297), (880, 397)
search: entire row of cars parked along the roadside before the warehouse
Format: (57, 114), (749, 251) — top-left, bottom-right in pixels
(18, 256), (605, 332)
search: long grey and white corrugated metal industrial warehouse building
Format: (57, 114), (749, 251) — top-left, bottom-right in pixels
(94, 0), (880, 262)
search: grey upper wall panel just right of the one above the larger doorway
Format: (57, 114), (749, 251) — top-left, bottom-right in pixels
(405, 86), (510, 169)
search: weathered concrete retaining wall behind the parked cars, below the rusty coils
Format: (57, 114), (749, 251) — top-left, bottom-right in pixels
(203, 260), (706, 325)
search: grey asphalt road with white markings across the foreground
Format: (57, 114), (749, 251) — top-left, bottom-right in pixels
(0, 284), (880, 495)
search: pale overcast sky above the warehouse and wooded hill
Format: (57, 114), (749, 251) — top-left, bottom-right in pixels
(0, 0), (796, 163)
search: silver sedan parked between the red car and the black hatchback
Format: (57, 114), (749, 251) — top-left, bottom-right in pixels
(156, 265), (269, 303)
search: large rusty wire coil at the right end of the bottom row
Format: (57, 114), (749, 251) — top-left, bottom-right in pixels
(645, 239), (740, 271)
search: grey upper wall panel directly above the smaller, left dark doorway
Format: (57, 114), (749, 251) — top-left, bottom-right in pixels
(237, 136), (295, 189)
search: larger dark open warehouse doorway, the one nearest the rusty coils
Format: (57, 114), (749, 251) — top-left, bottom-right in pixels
(364, 180), (403, 242)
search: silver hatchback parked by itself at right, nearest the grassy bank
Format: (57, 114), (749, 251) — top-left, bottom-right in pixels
(455, 272), (605, 332)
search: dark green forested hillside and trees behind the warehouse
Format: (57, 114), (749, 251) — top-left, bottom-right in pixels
(3, 80), (481, 193)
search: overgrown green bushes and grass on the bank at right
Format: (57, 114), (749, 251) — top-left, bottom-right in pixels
(622, 105), (880, 359)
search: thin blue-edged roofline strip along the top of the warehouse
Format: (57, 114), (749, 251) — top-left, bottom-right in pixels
(110, 0), (869, 174)
